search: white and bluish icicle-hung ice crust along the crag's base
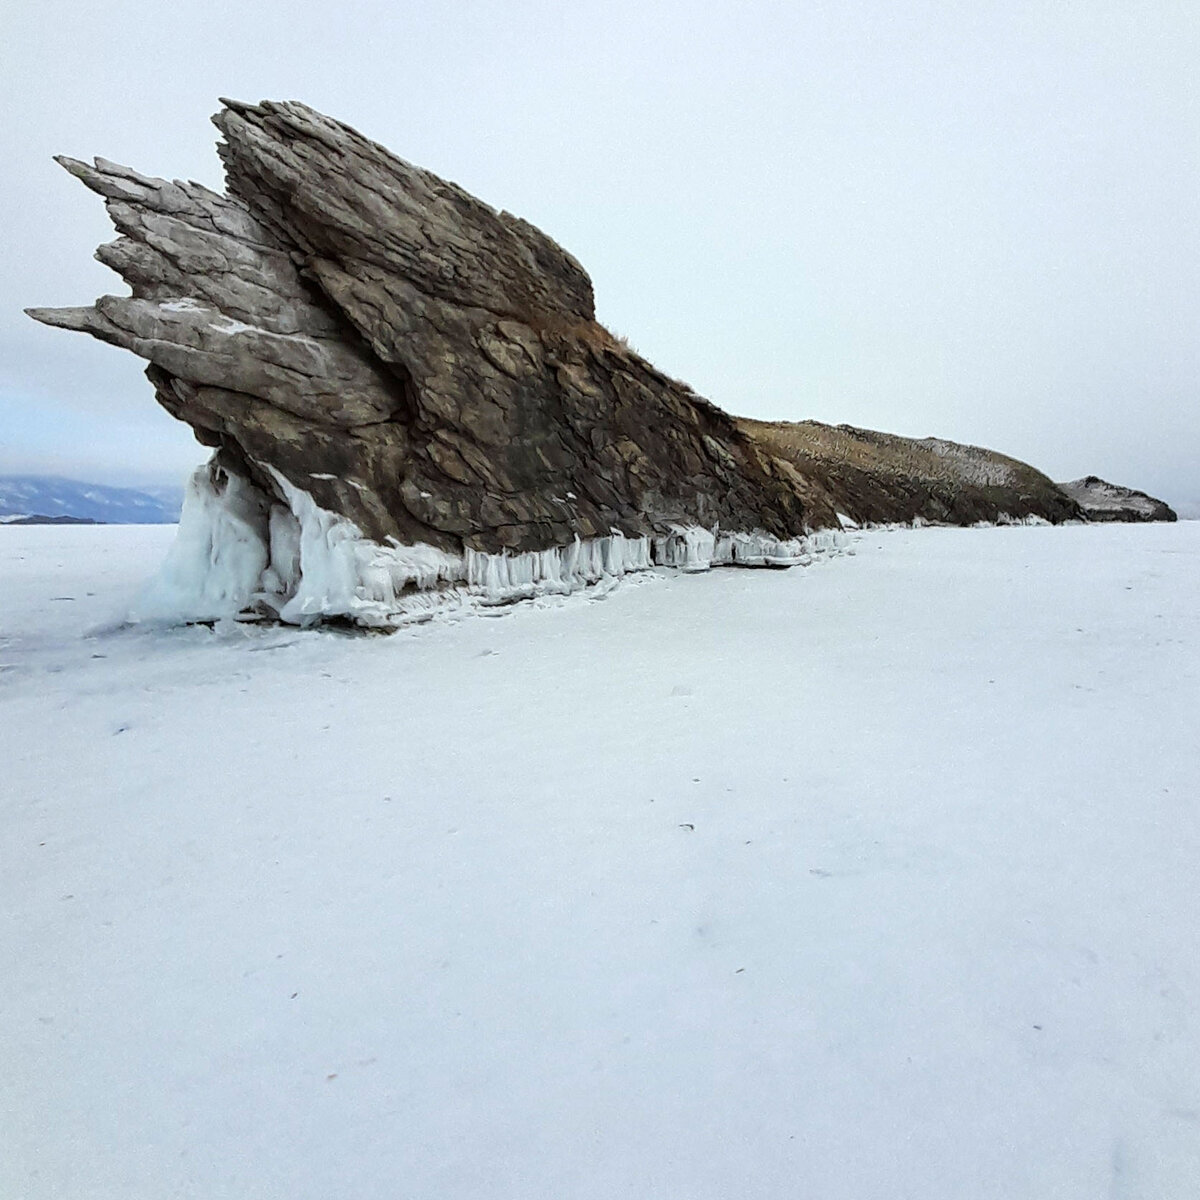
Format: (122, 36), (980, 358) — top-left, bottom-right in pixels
(133, 463), (846, 629)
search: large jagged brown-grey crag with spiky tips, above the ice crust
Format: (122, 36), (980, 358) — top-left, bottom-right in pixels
(31, 102), (827, 561)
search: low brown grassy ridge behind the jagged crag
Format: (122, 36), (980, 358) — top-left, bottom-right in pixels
(738, 420), (1080, 524)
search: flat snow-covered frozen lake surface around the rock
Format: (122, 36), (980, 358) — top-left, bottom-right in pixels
(0, 523), (1200, 1200)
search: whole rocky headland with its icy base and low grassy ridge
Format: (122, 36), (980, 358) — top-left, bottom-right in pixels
(29, 101), (1078, 624)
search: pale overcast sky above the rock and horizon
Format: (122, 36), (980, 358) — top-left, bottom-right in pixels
(0, 0), (1200, 500)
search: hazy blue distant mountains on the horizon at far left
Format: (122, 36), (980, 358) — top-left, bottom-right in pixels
(0, 475), (184, 524)
